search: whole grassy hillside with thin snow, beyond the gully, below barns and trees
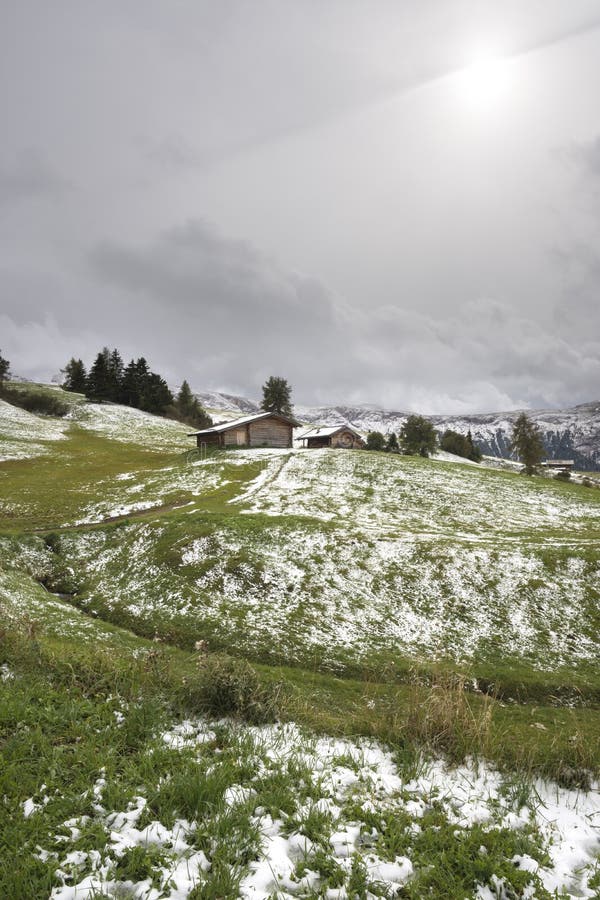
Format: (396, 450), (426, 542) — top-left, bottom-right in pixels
(0, 394), (600, 699)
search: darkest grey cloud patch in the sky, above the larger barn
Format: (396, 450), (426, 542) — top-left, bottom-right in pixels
(90, 221), (333, 341)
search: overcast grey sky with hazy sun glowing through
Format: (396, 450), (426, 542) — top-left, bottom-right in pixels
(0, 0), (600, 413)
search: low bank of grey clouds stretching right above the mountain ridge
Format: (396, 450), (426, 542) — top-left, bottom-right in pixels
(82, 221), (600, 412)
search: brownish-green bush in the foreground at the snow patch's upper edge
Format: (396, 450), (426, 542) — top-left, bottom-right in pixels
(183, 653), (281, 724)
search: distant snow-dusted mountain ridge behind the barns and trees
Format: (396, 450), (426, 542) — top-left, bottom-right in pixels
(197, 391), (600, 471)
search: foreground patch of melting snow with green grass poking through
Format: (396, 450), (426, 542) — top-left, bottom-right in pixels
(34, 714), (600, 900)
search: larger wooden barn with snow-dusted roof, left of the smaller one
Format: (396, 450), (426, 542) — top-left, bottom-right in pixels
(188, 412), (300, 447)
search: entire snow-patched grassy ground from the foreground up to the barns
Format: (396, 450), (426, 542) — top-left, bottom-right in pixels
(0, 389), (600, 900)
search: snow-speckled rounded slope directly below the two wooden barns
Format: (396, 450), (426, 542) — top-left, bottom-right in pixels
(37, 442), (600, 671)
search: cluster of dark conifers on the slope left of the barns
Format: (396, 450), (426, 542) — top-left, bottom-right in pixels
(61, 347), (213, 429)
